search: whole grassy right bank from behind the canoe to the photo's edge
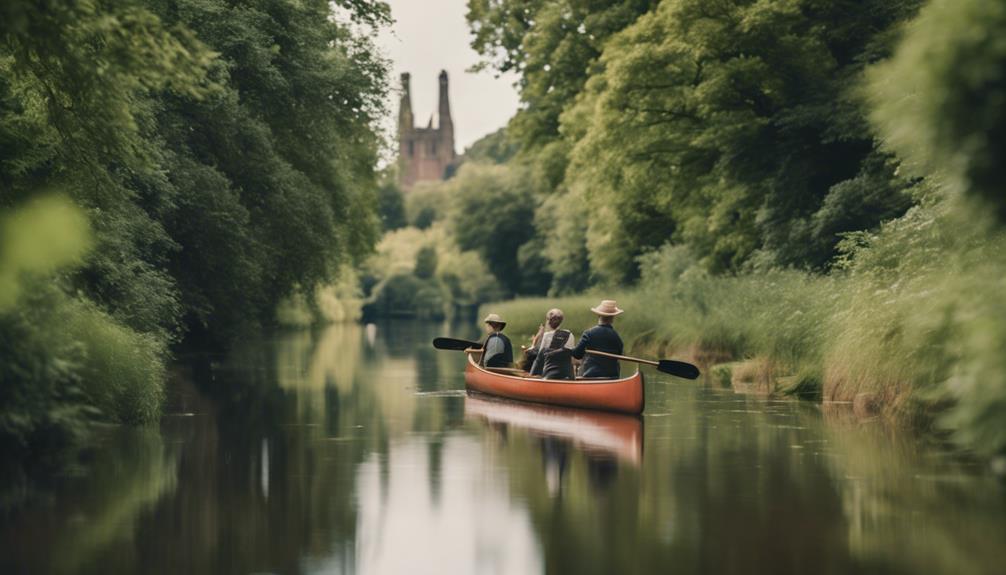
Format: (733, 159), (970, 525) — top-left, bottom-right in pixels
(483, 202), (1006, 454)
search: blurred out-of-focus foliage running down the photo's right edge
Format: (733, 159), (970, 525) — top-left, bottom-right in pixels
(867, 0), (1006, 455)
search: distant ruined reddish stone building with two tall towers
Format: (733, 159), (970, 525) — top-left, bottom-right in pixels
(398, 70), (456, 191)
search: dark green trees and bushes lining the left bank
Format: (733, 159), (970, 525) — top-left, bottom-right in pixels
(0, 0), (389, 466)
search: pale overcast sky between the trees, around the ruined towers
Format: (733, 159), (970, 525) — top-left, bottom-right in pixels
(378, 0), (518, 154)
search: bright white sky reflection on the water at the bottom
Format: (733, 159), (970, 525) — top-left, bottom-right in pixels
(356, 433), (540, 574)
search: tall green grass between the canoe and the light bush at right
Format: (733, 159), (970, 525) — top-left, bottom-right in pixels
(483, 248), (841, 371)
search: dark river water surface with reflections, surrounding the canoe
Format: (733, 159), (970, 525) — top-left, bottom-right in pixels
(0, 324), (1006, 574)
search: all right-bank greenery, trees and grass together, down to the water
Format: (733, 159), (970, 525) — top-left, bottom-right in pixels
(468, 0), (1006, 453)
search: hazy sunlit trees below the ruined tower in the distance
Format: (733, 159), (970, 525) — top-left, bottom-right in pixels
(359, 130), (523, 319)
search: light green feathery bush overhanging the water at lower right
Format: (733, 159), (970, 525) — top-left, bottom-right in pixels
(825, 199), (1006, 448)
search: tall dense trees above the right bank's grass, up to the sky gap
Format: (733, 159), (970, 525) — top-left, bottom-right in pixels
(468, 0), (919, 285)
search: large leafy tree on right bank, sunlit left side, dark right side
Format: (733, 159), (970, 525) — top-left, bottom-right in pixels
(563, 0), (916, 281)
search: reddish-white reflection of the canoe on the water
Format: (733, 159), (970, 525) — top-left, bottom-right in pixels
(465, 392), (643, 466)
